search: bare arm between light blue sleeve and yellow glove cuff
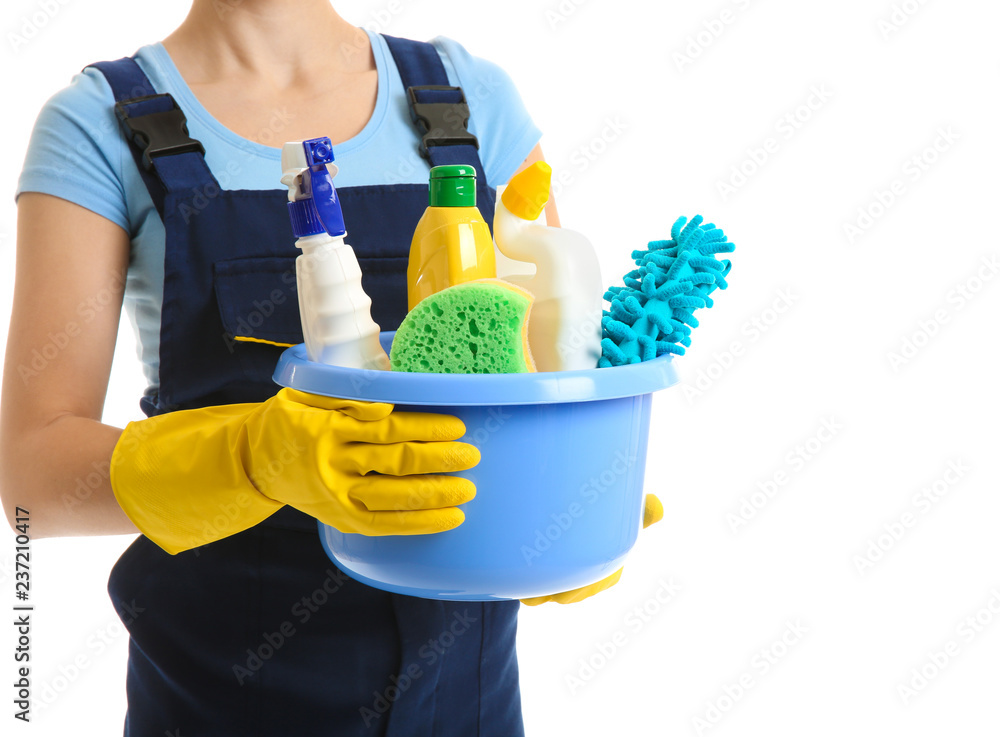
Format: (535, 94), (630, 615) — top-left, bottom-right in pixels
(0, 192), (137, 537)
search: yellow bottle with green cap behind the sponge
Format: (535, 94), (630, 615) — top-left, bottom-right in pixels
(406, 165), (497, 310)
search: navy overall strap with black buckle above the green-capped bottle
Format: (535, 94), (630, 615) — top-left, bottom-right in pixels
(382, 34), (493, 188)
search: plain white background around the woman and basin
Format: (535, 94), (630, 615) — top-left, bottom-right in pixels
(0, 0), (1000, 735)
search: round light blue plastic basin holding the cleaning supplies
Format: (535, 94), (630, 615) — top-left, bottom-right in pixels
(274, 332), (677, 601)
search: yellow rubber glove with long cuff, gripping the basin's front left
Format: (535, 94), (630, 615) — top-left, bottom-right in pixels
(111, 388), (480, 554)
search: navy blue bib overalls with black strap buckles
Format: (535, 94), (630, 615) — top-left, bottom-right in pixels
(93, 36), (523, 737)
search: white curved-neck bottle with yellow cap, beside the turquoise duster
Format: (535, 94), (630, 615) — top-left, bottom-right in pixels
(493, 161), (605, 371)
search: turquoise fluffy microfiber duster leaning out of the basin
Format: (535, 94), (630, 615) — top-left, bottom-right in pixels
(597, 215), (736, 368)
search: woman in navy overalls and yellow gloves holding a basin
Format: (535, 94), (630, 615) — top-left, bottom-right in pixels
(0, 0), (617, 736)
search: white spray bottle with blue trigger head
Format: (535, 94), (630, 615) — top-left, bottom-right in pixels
(281, 138), (389, 371)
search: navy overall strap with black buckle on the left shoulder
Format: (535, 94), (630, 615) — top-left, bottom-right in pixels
(90, 57), (219, 219)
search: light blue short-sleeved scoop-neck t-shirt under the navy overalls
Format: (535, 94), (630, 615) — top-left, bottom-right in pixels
(17, 31), (541, 392)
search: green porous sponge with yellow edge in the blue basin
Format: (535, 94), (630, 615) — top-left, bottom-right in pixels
(390, 279), (535, 374)
